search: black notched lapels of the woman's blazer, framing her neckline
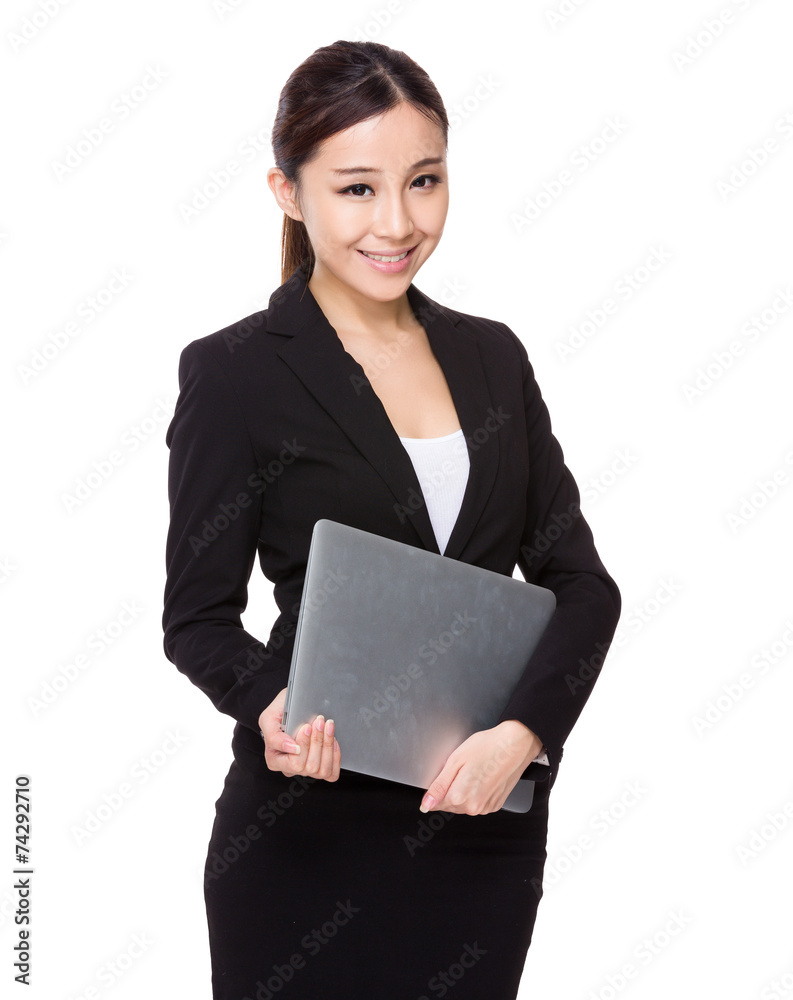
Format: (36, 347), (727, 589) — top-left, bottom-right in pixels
(266, 268), (499, 559)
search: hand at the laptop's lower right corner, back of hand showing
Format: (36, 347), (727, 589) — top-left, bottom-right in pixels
(421, 719), (542, 816)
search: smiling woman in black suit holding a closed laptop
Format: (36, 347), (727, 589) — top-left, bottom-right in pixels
(163, 41), (620, 1000)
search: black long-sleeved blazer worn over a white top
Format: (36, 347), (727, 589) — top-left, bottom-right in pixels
(162, 268), (620, 784)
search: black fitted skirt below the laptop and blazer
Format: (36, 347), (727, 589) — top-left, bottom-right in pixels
(204, 737), (550, 1000)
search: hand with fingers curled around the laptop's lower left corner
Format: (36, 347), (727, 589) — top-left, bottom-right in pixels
(259, 688), (341, 781)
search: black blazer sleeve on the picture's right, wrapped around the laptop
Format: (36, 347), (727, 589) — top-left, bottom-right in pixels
(498, 328), (621, 782)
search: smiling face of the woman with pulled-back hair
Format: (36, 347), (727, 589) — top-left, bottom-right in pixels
(282, 103), (449, 302)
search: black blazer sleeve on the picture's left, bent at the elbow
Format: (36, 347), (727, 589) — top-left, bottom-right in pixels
(162, 341), (289, 733)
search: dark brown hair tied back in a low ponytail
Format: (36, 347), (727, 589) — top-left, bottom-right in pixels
(272, 40), (449, 284)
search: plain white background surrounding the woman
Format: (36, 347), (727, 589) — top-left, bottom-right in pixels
(0, 0), (793, 1000)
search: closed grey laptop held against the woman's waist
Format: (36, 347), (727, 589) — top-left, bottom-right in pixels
(282, 518), (556, 812)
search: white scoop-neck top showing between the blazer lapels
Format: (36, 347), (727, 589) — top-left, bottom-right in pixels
(399, 428), (550, 764)
